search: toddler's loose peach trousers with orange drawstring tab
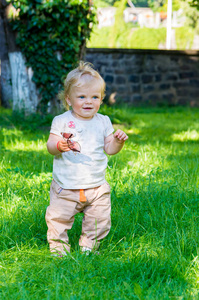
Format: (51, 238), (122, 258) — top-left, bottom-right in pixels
(46, 180), (111, 253)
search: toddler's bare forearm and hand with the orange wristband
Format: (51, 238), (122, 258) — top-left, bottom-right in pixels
(47, 133), (71, 155)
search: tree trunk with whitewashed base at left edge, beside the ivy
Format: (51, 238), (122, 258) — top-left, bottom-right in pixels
(0, 0), (39, 114)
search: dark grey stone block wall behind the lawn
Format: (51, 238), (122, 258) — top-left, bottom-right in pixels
(85, 48), (199, 107)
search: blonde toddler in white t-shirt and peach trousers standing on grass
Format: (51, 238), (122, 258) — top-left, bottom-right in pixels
(46, 62), (128, 255)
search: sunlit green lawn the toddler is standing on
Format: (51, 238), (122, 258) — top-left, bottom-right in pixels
(0, 105), (199, 300)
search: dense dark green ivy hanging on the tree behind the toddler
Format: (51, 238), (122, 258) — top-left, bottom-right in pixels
(7, 0), (94, 111)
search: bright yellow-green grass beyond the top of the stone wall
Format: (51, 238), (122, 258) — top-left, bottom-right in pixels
(87, 23), (194, 50)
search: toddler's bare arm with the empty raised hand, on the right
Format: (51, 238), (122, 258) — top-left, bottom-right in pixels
(104, 129), (128, 155)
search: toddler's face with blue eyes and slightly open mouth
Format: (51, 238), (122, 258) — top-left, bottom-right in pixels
(66, 75), (102, 120)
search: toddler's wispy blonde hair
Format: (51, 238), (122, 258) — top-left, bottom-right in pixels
(58, 61), (106, 109)
